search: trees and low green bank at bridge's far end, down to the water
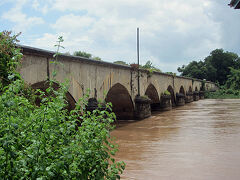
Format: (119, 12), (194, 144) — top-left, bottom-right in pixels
(178, 49), (240, 99)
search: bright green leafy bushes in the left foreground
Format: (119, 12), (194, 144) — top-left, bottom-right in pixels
(0, 32), (125, 179)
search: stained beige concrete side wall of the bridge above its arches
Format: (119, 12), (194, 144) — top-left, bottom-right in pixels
(19, 46), (217, 118)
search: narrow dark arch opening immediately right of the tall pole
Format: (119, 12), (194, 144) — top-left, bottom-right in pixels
(145, 84), (160, 111)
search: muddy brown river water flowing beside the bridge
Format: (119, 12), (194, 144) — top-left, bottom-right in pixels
(112, 100), (240, 180)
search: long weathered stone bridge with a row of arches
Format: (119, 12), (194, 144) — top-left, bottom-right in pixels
(19, 46), (217, 119)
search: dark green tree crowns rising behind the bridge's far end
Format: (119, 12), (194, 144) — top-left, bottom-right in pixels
(178, 49), (240, 85)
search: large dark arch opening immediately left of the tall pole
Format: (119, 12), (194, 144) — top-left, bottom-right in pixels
(105, 83), (134, 119)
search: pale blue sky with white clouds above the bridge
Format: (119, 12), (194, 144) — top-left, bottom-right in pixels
(0, 0), (240, 72)
